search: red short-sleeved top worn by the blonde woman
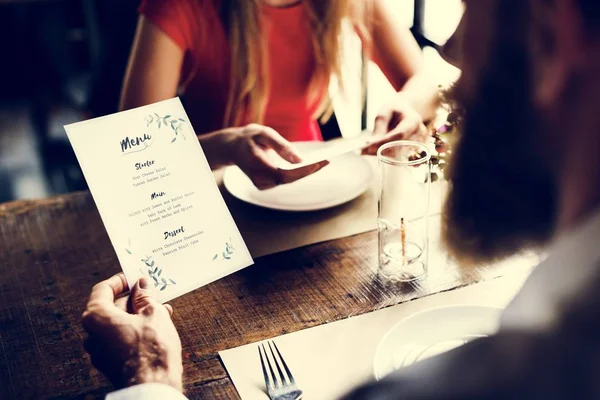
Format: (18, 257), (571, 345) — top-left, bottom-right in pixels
(139, 0), (326, 141)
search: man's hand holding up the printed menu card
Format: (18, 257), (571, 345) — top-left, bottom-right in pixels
(82, 273), (183, 391)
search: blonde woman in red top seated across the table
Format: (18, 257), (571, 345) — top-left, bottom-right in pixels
(121, 0), (437, 188)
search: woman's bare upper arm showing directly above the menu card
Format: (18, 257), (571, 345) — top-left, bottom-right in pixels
(120, 16), (183, 110)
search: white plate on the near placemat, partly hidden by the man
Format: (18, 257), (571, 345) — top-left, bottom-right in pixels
(373, 306), (502, 380)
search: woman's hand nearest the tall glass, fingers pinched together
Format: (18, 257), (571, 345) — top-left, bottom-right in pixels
(363, 92), (427, 155)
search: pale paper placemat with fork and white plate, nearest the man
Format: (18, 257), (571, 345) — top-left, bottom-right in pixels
(219, 268), (533, 400)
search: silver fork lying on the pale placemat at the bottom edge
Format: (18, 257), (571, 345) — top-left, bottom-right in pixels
(258, 341), (303, 400)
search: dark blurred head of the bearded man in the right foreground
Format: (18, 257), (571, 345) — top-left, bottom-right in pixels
(443, 0), (600, 264)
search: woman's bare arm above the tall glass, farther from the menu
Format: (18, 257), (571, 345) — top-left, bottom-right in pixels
(371, 0), (438, 121)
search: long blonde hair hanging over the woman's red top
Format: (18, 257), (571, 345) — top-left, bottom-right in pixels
(221, 0), (368, 127)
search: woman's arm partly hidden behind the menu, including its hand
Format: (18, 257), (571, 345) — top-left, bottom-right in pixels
(120, 16), (326, 189)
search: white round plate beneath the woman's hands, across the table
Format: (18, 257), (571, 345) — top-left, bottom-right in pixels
(223, 142), (373, 211)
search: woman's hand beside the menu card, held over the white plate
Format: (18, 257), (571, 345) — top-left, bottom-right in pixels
(225, 124), (328, 190)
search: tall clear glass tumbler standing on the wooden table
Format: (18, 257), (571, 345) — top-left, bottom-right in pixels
(377, 140), (431, 282)
